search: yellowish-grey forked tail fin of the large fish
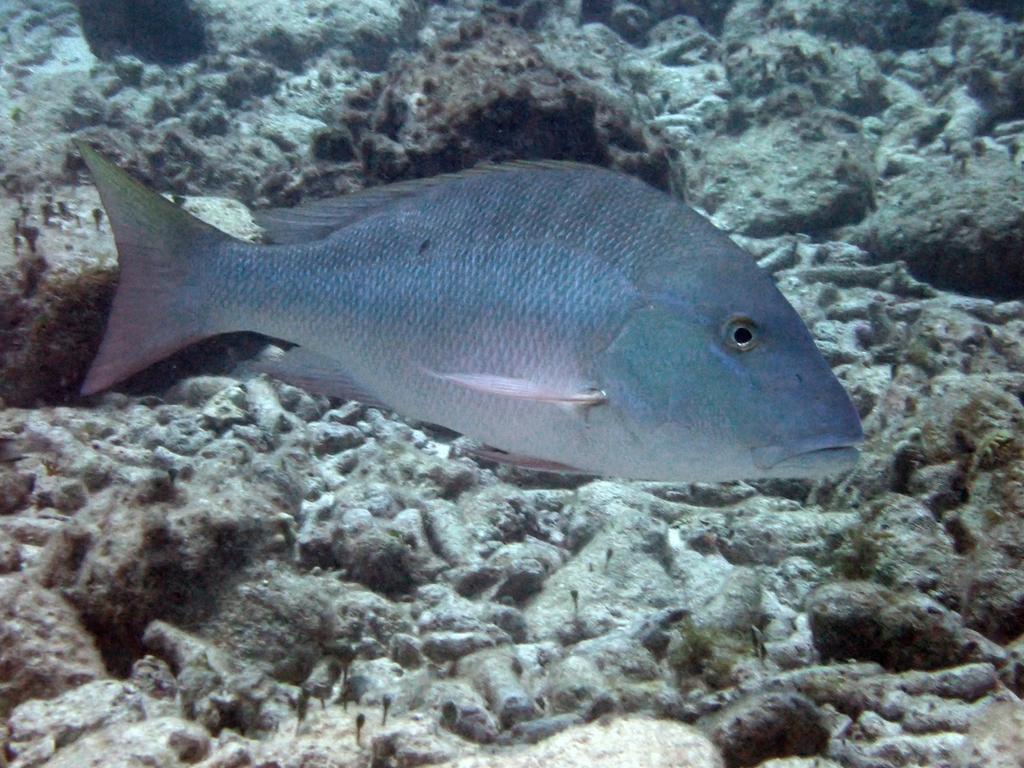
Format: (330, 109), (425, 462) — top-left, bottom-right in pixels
(75, 141), (232, 395)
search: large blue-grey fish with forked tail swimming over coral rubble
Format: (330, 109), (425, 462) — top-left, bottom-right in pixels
(77, 142), (863, 482)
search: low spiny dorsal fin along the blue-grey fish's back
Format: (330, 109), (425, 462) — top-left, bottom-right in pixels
(253, 160), (606, 245)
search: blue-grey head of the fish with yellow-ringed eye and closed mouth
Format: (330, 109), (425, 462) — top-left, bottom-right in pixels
(597, 254), (863, 480)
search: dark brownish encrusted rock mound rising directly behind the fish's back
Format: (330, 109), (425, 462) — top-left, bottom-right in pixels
(346, 14), (670, 188)
